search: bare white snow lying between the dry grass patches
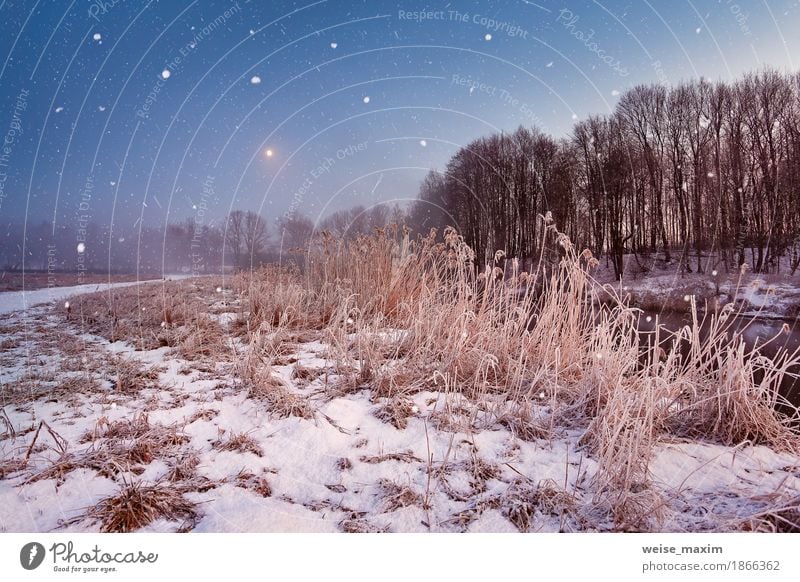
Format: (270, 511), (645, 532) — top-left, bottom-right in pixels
(0, 283), (800, 532)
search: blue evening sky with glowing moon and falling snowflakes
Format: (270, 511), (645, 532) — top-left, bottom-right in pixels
(0, 0), (800, 238)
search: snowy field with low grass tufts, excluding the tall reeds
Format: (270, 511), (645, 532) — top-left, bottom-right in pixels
(0, 283), (800, 532)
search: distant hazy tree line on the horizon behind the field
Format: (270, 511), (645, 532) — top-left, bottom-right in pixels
(0, 204), (407, 275)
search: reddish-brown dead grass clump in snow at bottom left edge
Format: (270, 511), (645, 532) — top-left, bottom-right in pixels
(84, 482), (198, 533)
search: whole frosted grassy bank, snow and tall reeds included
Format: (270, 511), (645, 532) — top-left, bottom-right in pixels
(0, 227), (800, 532)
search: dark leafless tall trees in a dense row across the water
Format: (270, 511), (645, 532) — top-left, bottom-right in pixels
(409, 69), (800, 277)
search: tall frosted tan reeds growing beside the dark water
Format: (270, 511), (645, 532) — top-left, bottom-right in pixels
(242, 225), (800, 530)
